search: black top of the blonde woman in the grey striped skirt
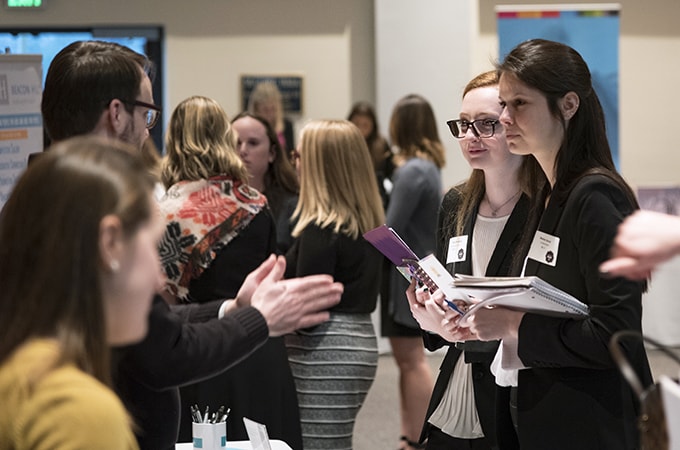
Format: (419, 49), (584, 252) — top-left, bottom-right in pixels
(286, 224), (382, 313)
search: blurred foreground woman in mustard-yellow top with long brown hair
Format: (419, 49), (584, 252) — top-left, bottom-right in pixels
(0, 137), (163, 449)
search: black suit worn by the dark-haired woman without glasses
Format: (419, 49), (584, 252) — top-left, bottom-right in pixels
(518, 175), (652, 450)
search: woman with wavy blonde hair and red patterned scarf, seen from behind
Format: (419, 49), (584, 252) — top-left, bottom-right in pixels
(159, 96), (301, 449)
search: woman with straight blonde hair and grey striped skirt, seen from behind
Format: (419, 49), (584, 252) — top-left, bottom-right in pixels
(286, 121), (383, 449)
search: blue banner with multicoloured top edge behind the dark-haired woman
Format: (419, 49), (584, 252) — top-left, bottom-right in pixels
(496, 4), (621, 167)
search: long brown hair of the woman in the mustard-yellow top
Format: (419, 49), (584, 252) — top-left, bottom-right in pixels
(0, 136), (154, 384)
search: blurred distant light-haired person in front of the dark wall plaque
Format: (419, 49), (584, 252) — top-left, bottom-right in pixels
(248, 81), (295, 154)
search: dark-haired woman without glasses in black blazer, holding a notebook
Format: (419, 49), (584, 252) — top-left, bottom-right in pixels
(446, 39), (652, 450)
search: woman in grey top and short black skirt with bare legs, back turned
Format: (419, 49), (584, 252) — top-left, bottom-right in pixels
(380, 94), (445, 449)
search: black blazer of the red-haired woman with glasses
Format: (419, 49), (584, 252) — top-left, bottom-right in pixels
(421, 189), (529, 448)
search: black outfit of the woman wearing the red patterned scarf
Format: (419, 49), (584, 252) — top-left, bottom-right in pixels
(179, 209), (302, 450)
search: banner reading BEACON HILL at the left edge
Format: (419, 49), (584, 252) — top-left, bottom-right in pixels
(0, 55), (43, 209)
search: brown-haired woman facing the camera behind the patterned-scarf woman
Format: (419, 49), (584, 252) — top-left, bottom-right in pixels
(231, 112), (299, 254)
